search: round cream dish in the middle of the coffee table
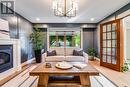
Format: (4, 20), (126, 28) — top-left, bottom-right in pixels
(55, 61), (73, 69)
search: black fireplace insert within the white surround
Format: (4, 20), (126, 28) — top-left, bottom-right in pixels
(0, 45), (13, 73)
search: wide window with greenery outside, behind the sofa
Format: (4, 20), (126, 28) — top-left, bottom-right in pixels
(49, 31), (80, 47)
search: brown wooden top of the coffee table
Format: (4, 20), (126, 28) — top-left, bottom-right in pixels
(30, 62), (99, 76)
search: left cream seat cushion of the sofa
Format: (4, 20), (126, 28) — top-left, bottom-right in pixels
(45, 56), (65, 62)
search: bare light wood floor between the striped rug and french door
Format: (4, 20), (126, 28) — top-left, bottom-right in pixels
(89, 61), (130, 87)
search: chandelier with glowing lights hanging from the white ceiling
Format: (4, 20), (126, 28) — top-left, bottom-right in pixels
(53, 0), (78, 17)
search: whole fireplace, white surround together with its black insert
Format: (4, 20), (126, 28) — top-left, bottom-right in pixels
(0, 39), (21, 80)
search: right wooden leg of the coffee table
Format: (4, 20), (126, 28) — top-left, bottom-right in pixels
(80, 75), (91, 87)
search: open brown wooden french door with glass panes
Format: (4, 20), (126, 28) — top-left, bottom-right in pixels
(100, 20), (123, 71)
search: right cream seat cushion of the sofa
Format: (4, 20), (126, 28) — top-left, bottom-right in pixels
(65, 56), (84, 62)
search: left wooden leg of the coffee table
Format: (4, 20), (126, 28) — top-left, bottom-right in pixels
(38, 75), (49, 87)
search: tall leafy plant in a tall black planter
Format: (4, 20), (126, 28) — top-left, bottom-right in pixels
(30, 25), (44, 63)
